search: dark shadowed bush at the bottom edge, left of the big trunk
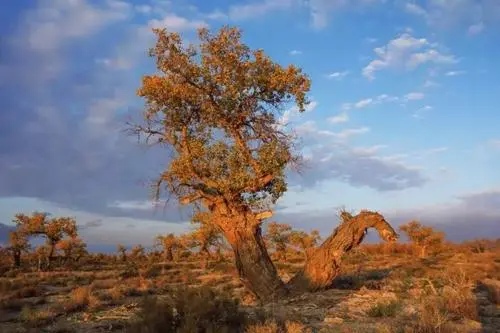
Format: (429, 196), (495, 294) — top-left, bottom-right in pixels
(127, 288), (246, 333)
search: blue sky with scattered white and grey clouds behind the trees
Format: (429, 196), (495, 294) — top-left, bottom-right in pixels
(0, 0), (500, 244)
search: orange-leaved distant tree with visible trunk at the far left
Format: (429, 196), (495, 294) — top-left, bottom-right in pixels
(13, 213), (78, 268)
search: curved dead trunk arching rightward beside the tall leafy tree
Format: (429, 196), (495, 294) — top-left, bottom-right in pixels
(288, 212), (398, 292)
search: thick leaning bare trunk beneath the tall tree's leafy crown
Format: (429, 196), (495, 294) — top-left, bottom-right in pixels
(224, 220), (288, 301)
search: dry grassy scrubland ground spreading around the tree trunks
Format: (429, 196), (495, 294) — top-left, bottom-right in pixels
(0, 244), (500, 333)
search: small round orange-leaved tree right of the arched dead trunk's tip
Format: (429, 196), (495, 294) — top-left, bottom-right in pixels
(399, 221), (444, 258)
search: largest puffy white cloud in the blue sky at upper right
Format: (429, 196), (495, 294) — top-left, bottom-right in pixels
(362, 33), (457, 80)
